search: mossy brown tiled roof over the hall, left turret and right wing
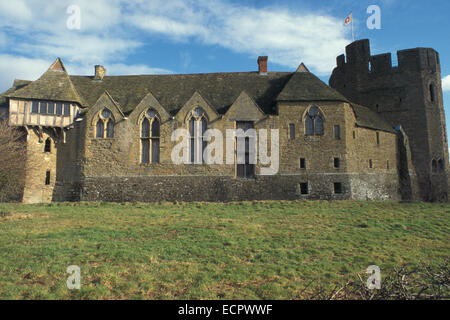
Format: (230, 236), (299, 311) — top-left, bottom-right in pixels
(0, 59), (395, 132)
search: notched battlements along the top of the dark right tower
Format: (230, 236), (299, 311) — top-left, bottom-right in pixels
(335, 39), (440, 74)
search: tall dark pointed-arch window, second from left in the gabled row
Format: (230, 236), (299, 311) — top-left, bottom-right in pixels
(141, 109), (161, 163)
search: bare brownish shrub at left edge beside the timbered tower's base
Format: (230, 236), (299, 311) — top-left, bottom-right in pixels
(0, 120), (27, 202)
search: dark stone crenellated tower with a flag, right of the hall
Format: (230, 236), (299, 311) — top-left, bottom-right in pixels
(330, 39), (449, 201)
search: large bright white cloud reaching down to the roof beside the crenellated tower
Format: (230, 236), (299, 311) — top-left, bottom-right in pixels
(126, 0), (348, 74)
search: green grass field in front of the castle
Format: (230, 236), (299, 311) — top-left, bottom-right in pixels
(0, 202), (450, 299)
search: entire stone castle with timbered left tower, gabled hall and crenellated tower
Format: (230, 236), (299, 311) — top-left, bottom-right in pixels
(0, 40), (449, 203)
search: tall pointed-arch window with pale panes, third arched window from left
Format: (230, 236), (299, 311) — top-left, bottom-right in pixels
(189, 107), (208, 164)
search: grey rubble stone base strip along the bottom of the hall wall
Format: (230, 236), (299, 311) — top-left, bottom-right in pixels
(54, 174), (399, 202)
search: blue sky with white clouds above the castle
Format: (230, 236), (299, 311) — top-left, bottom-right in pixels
(0, 0), (450, 130)
